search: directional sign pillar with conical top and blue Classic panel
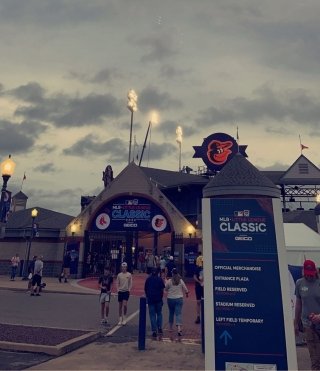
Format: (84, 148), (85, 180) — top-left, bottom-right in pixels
(202, 155), (297, 370)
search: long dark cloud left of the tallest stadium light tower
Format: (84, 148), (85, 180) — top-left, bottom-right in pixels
(14, 85), (125, 127)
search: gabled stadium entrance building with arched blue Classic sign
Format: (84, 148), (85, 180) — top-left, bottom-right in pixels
(66, 162), (201, 277)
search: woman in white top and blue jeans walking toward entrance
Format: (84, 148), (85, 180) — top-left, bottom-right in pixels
(165, 268), (189, 339)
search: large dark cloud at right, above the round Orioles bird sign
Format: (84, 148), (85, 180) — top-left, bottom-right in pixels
(196, 85), (320, 128)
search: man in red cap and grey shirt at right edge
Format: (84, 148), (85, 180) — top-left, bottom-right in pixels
(294, 260), (320, 370)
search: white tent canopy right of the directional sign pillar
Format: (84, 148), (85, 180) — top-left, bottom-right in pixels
(283, 223), (320, 266)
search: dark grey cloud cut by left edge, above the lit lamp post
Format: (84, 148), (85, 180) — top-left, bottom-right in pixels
(0, 120), (47, 155)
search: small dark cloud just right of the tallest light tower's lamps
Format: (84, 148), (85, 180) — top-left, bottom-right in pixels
(138, 86), (183, 112)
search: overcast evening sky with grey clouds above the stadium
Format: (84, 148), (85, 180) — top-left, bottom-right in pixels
(0, 0), (320, 215)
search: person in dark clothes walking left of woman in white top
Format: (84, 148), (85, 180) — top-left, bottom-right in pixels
(144, 268), (165, 339)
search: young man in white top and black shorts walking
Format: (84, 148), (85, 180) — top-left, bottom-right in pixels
(117, 262), (132, 326)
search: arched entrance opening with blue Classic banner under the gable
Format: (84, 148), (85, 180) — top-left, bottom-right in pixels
(83, 194), (174, 276)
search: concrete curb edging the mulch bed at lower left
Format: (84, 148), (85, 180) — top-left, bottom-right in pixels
(0, 332), (101, 357)
